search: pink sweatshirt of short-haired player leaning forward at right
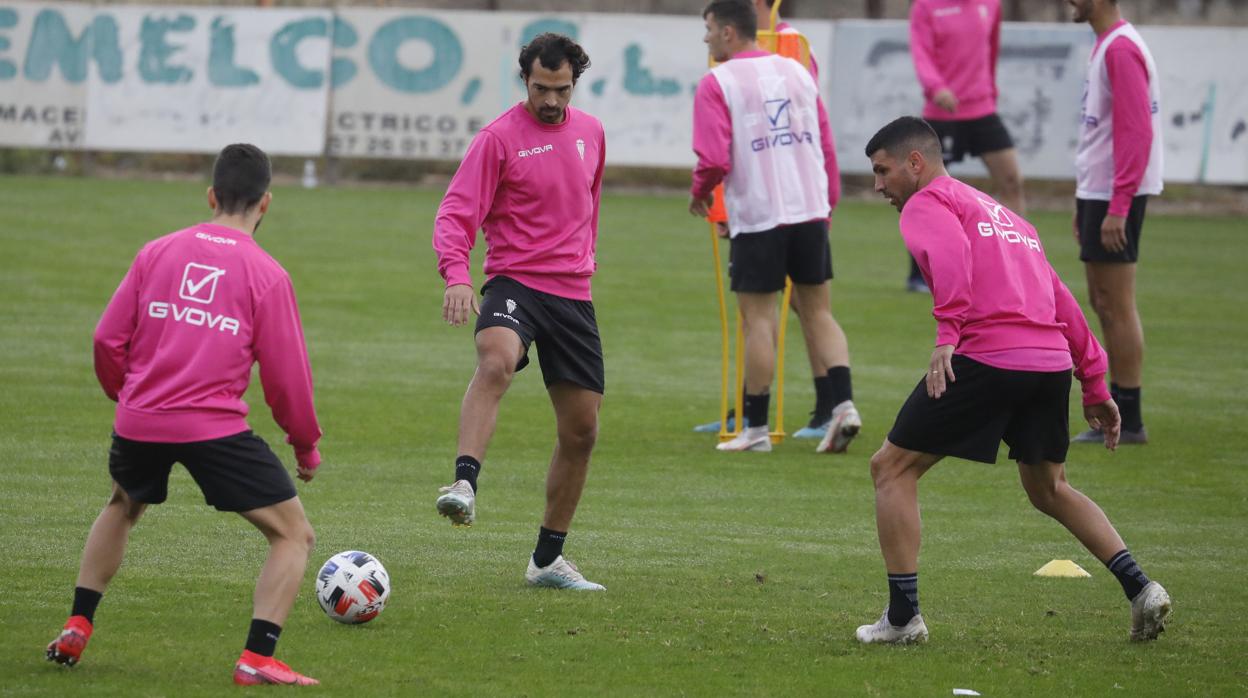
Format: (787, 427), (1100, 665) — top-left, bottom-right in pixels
(901, 176), (1109, 405)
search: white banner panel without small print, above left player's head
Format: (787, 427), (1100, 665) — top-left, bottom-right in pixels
(86, 5), (332, 155)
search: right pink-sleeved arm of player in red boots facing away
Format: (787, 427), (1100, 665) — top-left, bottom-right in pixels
(252, 276), (321, 482)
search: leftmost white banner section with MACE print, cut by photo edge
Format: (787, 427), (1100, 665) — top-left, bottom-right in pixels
(0, 2), (90, 150)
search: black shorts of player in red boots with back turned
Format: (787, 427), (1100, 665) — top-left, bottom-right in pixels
(109, 431), (296, 512)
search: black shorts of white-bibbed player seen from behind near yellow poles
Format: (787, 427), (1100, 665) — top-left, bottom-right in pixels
(728, 220), (832, 293)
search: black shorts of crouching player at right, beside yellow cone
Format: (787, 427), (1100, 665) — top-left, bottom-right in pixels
(889, 355), (1071, 465)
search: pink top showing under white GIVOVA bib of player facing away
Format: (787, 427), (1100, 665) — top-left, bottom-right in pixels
(690, 50), (841, 209)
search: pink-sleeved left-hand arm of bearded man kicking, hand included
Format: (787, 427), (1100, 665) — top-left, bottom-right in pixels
(433, 131), (507, 325)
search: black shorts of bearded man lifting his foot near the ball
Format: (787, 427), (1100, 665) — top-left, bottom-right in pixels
(477, 276), (607, 395)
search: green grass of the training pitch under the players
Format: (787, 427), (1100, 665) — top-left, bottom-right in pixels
(0, 177), (1248, 696)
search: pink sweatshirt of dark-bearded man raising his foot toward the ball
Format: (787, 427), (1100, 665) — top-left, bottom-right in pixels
(433, 102), (607, 301)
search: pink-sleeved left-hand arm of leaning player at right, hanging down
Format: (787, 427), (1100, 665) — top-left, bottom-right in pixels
(901, 195), (972, 398)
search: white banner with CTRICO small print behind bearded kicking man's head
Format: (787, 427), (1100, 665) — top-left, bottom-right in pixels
(329, 9), (831, 167)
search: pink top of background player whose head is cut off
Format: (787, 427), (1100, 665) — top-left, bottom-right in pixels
(910, 0), (1001, 121)
